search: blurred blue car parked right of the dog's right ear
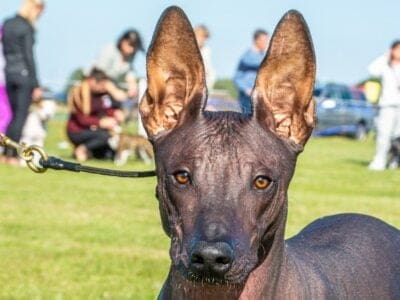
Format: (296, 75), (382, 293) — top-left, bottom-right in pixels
(314, 84), (376, 140)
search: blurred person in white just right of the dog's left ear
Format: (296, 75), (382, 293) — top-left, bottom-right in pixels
(194, 25), (216, 92)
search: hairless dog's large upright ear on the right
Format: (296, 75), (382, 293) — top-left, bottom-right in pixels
(252, 10), (316, 146)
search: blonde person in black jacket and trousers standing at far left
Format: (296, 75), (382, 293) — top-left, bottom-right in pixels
(3, 0), (44, 164)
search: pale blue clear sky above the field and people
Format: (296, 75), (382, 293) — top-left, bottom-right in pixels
(0, 0), (400, 89)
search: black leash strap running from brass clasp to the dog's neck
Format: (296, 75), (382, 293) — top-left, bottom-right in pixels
(39, 156), (156, 178)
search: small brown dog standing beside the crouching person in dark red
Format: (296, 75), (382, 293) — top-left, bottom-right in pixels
(114, 133), (154, 166)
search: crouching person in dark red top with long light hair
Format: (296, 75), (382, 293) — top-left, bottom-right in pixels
(67, 68), (124, 161)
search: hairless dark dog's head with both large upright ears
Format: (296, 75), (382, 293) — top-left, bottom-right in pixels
(140, 7), (315, 284)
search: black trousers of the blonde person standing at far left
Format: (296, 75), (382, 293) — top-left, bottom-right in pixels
(5, 74), (33, 156)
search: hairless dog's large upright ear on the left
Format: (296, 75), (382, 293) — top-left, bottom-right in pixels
(140, 6), (207, 139)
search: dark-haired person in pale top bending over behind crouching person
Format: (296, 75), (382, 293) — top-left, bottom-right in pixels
(86, 29), (143, 102)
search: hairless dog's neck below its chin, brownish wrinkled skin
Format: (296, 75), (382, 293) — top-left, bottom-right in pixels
(159, 210), (296, 300)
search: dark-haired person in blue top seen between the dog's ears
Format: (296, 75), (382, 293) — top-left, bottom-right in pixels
(233, 29), (269, 114)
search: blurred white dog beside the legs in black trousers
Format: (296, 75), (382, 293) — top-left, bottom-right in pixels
(21, 100), (57, 147)
